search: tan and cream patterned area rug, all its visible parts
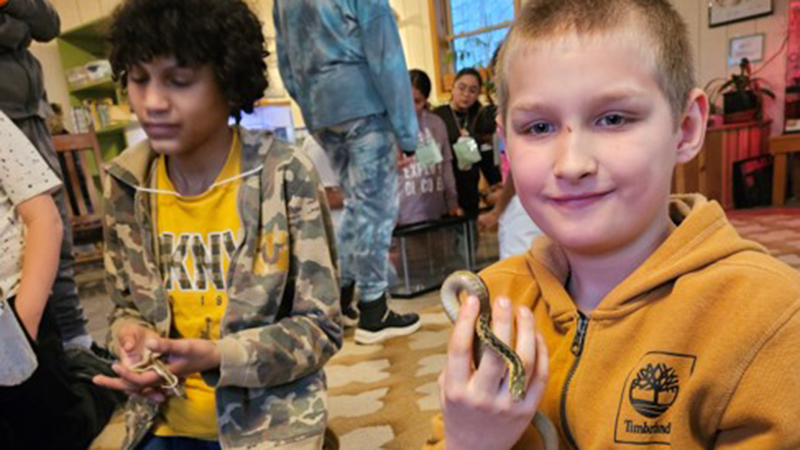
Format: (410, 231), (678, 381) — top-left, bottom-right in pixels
(92, 209), (800, 450)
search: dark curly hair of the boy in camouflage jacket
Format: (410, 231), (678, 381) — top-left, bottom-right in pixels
(108, 0), (269, 122)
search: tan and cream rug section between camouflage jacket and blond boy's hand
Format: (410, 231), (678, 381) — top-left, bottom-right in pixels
(326, 306), (451, 450)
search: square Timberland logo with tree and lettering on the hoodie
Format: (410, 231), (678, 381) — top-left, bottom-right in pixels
(614, 351), (697, 446)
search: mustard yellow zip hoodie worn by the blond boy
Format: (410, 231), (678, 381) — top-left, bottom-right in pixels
(427, 196), (800, 450)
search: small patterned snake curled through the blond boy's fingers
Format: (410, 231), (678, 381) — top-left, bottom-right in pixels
(440, 270), (558, 450)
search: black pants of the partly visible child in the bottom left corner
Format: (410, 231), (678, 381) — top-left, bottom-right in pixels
(0, 298), (124, 450)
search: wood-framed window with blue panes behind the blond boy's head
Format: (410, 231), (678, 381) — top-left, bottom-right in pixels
(429, 0), (521, 92)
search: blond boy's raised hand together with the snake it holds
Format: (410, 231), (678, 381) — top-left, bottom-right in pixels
(439, 272), (558, 450)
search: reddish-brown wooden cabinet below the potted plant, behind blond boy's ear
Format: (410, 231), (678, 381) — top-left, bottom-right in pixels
(672, 120), (772, 209)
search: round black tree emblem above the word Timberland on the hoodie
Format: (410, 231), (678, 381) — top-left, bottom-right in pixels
(628, 363), (681, 419)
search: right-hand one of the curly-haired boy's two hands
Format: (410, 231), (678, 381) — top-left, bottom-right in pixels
(146, 336), (221, 378)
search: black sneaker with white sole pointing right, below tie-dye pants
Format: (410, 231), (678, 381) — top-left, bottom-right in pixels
(355, 294), (420, 344)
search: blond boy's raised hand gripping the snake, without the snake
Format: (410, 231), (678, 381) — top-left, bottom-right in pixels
(439, 297), (548, 449)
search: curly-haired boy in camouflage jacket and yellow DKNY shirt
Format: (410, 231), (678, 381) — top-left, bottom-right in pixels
(95, 0), (342, 449)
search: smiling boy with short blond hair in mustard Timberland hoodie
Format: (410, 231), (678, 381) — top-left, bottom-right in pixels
(434, 0), (800, 450)
